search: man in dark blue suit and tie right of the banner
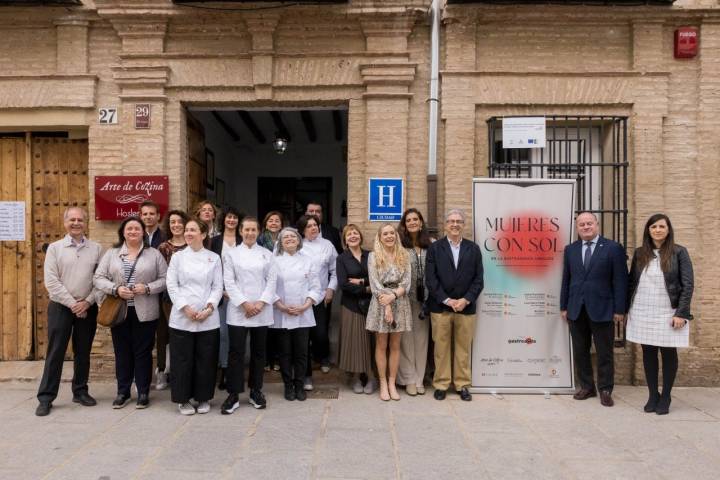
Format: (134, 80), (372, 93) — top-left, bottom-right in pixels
(560, 212), (628, 407)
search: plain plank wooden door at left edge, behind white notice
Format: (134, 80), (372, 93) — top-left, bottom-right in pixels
(0, 137), (32, 360)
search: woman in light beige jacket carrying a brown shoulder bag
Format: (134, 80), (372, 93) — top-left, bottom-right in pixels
(93, 217), (167, 408)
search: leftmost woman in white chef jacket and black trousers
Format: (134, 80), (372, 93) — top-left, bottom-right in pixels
(166, 219), (223, 415)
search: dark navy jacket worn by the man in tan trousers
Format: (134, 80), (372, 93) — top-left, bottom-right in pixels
(425, 237), (483, 315)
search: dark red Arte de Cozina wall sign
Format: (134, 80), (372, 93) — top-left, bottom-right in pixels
(95, 175), (170, 220)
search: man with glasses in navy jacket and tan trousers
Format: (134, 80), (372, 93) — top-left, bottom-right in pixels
(425, 210), (483, 401)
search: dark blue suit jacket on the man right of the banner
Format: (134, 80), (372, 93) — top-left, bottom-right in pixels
(560, 236), (628, 322)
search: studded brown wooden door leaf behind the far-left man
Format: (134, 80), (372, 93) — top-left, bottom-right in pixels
(32, 137), (89, 359)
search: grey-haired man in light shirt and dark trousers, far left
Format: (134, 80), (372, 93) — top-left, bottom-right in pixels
(35, 207), (102, 417)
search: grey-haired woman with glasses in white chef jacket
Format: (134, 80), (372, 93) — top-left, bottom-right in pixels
(273, 227), (325, 401)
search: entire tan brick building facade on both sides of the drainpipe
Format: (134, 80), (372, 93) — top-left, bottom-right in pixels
(0, 0), (720, 385)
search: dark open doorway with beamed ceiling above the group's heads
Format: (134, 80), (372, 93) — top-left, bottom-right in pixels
(188, 107), (348, 232)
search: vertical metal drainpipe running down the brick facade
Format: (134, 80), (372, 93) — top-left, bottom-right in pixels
(426, 0), (440, 235)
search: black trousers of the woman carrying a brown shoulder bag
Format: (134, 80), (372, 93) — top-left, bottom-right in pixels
(110, 307), (157, 396)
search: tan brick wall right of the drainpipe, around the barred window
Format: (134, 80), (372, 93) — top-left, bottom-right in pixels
(441, 2), (720, 385)
